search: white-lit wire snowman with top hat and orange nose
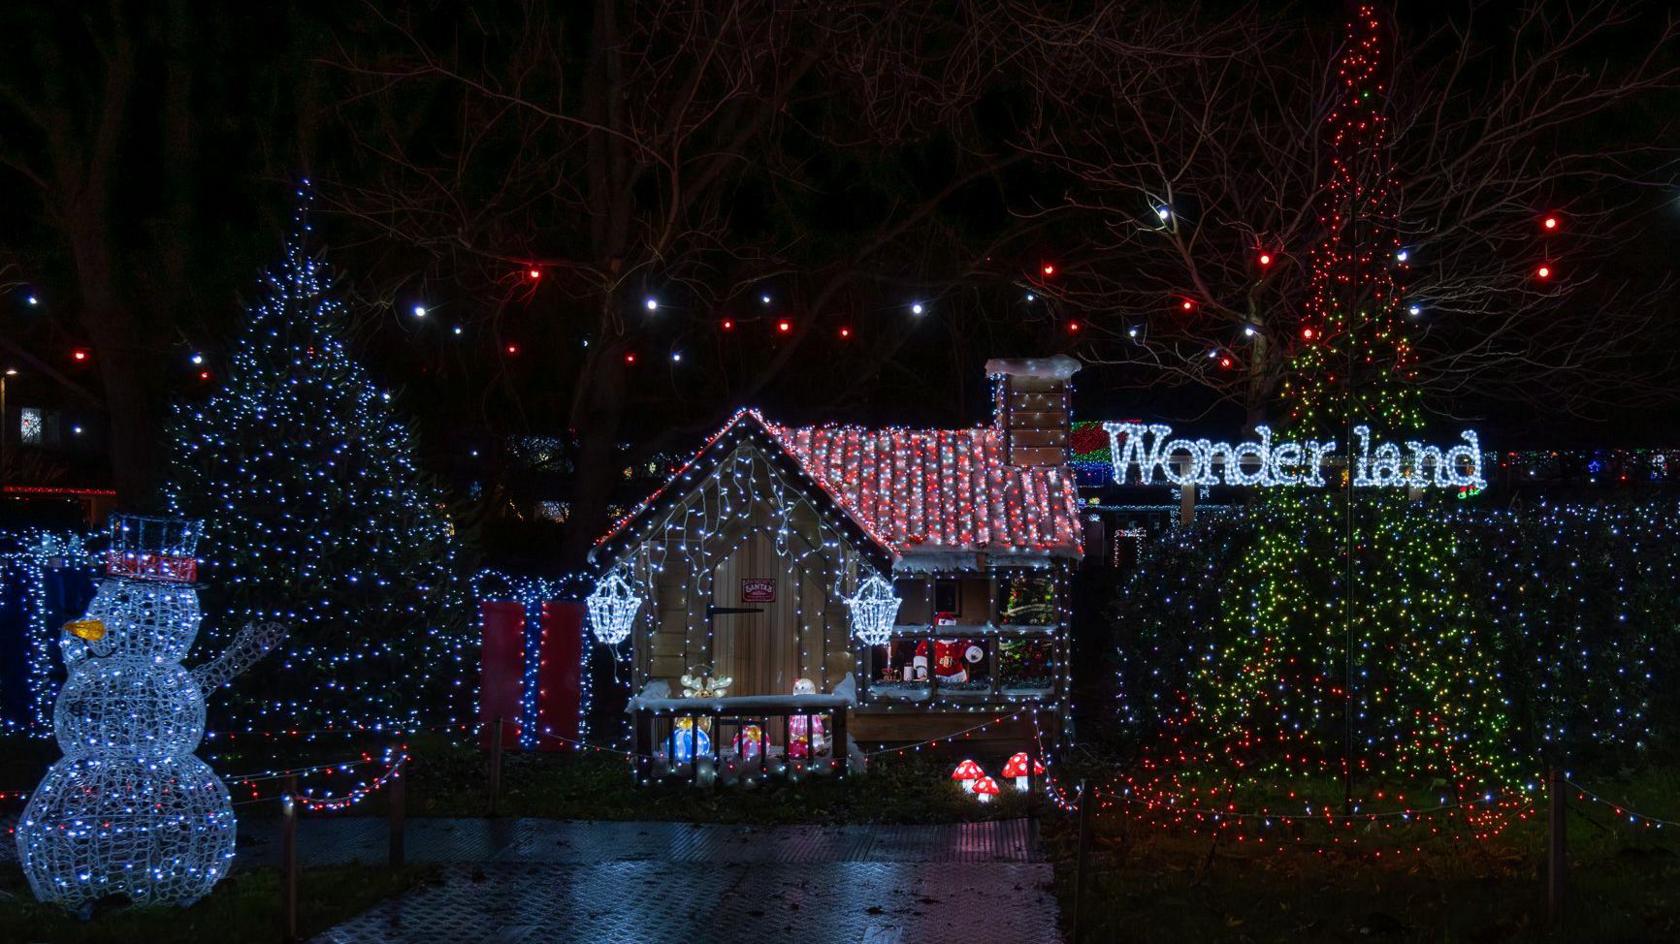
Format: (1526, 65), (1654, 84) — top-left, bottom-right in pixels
(17, 516), (286, 912)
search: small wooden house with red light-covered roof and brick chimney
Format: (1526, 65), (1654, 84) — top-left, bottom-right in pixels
(588, 356), (1082, 781)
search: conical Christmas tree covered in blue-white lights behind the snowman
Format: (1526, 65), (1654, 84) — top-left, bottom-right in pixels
(165, 191), (475, 729)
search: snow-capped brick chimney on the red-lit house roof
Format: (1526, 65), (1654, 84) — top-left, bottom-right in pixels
(986, 354), (1080, 467)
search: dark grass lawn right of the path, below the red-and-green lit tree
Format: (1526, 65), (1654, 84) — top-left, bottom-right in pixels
(1042, 773), (1680, 944)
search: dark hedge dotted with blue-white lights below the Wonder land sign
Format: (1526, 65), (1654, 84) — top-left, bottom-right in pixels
(1110, 501), (1680, 778)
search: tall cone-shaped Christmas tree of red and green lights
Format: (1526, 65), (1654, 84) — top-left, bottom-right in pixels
(1129, 5), (1532, 833)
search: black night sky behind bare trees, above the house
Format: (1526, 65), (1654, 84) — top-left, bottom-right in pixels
(0, 0), (1680, 513)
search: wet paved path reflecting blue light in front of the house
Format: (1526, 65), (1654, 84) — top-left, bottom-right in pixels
(250, 818), (1060, 944)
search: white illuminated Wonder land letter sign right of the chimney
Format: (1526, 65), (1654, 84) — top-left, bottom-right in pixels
(1102, 423), (1487, 489)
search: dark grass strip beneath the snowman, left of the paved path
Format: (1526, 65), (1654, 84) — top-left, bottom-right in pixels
(0, 860), (435, 944)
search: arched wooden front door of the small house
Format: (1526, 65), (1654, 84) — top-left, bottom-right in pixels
(712, 534), (806, 695)
